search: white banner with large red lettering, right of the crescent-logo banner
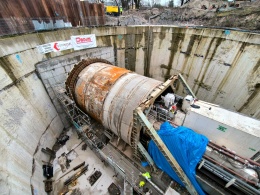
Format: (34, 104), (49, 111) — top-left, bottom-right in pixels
(70, 34), (97, 50)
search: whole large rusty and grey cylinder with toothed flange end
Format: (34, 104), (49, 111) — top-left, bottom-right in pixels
(66, 60), (162, 145)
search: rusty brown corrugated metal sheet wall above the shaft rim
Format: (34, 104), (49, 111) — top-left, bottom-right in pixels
(0, 0), (105, 35)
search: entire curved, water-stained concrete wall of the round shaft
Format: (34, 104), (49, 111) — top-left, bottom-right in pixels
(0, 26), (260, 194)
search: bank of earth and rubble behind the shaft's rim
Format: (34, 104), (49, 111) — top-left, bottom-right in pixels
(107, 0), (260, 31)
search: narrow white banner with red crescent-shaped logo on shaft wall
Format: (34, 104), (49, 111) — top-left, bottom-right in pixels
(37, 40), (73, 54)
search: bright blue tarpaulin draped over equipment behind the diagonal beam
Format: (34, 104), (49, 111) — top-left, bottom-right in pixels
(148, 122), (208, 195)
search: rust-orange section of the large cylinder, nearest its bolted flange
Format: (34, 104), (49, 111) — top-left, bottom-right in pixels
(75, 62), (129, 122)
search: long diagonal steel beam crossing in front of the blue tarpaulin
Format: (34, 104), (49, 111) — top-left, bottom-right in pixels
(134, 107), (198, 195)
